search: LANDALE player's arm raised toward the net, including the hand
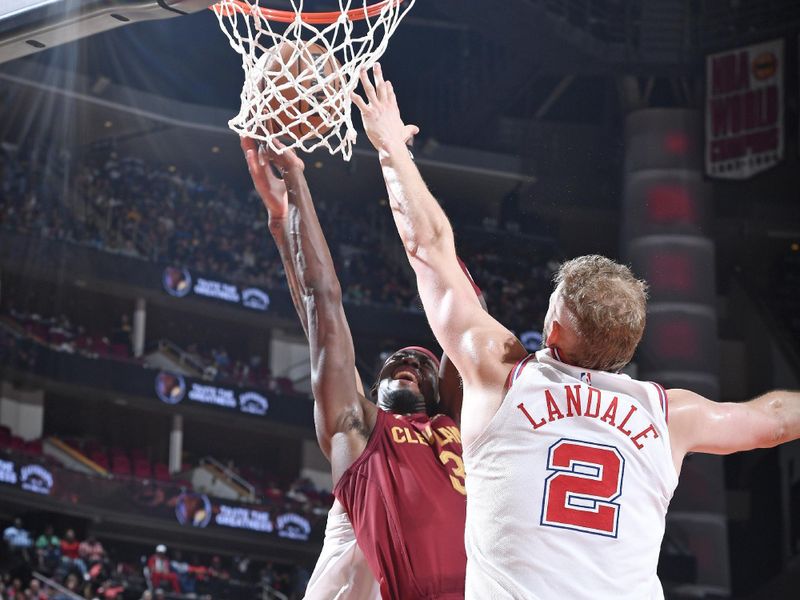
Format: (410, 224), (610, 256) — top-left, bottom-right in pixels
(353, 64), (525, 402)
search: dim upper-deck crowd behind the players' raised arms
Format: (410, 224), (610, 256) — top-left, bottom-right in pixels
(0, 141), (550, 328)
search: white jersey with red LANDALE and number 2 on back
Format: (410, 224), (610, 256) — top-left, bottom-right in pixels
(464, 349), (678, 600)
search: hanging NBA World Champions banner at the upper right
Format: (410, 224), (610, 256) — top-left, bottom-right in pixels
(706, 40), (784, 179)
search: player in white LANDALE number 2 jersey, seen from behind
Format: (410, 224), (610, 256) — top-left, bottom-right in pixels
(352, 65), (800, 600)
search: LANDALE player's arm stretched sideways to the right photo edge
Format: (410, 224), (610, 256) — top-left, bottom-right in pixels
(667, 389), (800, 470)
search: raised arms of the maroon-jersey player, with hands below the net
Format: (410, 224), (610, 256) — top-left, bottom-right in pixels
(242, 139), (372, 468)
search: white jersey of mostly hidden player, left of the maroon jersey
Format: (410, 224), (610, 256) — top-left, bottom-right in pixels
(305, 500), (381, 600)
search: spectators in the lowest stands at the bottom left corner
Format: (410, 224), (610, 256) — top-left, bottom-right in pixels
(0, 518), (307, 600)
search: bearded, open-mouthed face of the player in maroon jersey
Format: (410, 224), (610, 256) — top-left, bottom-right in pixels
(377, 350), (439, 414)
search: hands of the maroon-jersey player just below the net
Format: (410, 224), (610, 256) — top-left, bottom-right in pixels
(241, 137), (305, 221)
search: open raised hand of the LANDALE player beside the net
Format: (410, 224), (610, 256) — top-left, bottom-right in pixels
(350, 63), (419, 152)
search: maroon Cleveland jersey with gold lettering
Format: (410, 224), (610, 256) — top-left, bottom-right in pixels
(334, 410), (467, 600)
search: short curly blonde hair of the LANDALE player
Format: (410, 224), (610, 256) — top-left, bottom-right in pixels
(554, 254), (647, 372)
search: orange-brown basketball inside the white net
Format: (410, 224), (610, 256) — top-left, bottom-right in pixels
(257, 42), (341, 140)
